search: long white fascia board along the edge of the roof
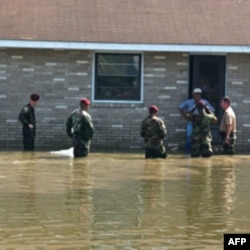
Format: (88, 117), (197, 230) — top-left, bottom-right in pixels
(0, 40), (250, 53)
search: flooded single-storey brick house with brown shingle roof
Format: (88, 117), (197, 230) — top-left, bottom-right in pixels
(0, 0), (250, 150)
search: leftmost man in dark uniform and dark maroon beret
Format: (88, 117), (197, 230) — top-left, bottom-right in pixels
(18, 93), (40, 151)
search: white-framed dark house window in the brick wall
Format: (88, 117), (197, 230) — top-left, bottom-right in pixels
(94, 53), (141, 101)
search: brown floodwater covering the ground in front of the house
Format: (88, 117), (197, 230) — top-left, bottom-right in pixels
(0, 150), (250, 250)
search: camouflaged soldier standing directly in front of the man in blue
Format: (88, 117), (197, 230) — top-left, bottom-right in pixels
(187, 101), (218, 157)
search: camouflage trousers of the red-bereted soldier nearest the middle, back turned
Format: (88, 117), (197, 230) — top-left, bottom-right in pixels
(145, 139), (167, 159)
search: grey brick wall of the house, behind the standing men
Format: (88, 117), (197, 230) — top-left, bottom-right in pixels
(0, 49), (250, 150)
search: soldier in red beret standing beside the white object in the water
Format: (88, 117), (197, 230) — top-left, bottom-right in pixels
(66, 98), (93, 158)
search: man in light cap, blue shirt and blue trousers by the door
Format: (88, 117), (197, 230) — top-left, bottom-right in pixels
(178, 88), (214, 153)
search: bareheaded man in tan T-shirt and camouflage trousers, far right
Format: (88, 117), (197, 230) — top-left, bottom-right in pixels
(220, 96), (236, 155)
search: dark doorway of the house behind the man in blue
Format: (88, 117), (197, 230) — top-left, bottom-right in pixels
(189, 56), (226, 144)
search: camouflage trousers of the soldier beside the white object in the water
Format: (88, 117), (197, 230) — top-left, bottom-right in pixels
(73, 135), (90, 158)
